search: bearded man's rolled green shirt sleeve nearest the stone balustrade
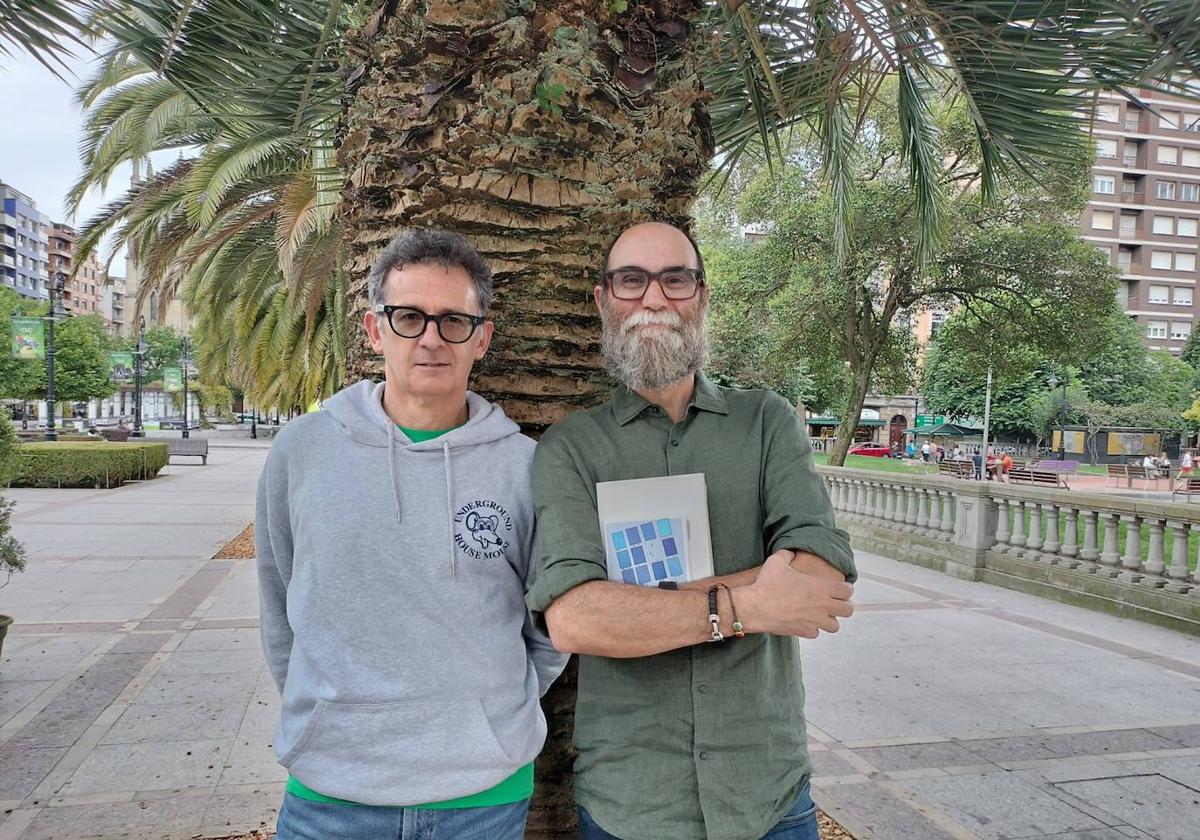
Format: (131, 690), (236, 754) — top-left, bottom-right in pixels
(762, 396), (858, 583)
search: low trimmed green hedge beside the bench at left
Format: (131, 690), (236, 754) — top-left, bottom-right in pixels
(12, 442), (168, 487)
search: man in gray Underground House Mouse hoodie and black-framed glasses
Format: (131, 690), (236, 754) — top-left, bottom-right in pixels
(254, 229), (566, 840)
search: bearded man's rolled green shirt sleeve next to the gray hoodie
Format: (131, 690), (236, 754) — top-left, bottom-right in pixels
(526, 428), (608, 632)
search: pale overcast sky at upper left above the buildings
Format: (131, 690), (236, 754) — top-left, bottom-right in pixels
(0, 53), (143, 276)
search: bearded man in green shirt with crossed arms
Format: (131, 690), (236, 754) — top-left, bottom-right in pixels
(527, 223), (856, 840)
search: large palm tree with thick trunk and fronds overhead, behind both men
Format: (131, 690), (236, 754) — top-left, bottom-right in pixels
(60, 0), (1200, 838)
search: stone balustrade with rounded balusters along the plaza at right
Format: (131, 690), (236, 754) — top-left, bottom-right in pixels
(818, 467), (1200, 634)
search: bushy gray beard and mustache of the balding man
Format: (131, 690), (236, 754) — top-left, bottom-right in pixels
(600, 300), (709, 391)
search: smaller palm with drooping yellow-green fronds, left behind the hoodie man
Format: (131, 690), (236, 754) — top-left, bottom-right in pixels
(71, 46), (347, 409)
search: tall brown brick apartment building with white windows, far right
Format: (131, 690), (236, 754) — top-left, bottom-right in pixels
(1080, 91), (1200, 353)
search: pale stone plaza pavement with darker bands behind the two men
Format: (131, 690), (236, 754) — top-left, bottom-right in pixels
(0, 445), (1200, 840)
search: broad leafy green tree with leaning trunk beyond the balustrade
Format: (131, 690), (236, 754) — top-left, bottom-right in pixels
(713, 97), (1116, 464)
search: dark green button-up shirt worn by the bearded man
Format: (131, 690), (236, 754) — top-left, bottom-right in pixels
(527, 374), (856, 840)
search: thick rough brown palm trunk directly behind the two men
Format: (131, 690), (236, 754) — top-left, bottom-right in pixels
(338, 0), (713, 840)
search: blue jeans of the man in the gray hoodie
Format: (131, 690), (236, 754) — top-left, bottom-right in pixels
(275, 793), (529, 840)
